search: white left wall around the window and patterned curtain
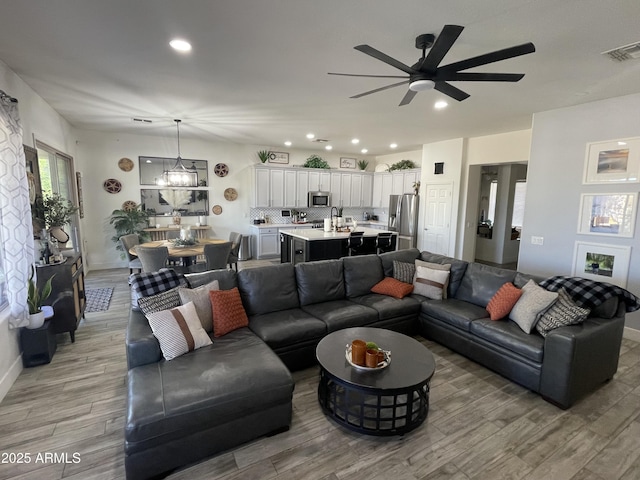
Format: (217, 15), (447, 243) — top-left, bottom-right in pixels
(0, 61), (75, 400)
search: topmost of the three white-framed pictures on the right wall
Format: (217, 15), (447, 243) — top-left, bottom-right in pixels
(583, 137), (640, 184)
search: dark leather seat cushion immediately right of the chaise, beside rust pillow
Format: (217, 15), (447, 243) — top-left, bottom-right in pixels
(249, 304), (327, 349)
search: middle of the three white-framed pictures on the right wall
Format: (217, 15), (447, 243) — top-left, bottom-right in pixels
(578, 193), (638, 238)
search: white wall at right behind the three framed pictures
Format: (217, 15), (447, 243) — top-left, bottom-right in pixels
(519, 94), (640, 329)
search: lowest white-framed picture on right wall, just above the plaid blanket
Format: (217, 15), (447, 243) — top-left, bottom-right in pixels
(571, 242), (631, 288)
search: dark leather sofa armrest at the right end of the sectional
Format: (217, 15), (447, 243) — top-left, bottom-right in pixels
(540, 315), (624, 408)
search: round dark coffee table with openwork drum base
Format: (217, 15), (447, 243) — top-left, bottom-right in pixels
(316, 327), (436, 435)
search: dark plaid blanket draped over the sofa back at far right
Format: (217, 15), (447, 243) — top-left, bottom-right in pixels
(540, 275), (640, 312)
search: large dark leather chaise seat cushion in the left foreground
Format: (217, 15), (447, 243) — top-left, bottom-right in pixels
(125, 328), (294, 448)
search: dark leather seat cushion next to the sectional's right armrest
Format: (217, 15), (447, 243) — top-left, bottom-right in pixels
(471, 319), (544, 363)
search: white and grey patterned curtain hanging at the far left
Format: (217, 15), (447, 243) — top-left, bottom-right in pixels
(0, 95), (34, 328)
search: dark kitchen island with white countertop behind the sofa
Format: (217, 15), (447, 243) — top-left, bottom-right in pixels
(280, 227), (397, 264)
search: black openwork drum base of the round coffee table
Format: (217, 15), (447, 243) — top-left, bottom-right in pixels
(318, 368), (430, 436)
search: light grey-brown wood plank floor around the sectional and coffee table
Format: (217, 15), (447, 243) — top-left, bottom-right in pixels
(0, 262), (640, 480)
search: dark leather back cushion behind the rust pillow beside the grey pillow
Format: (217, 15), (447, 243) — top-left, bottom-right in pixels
(455, 263), (516, 307)
